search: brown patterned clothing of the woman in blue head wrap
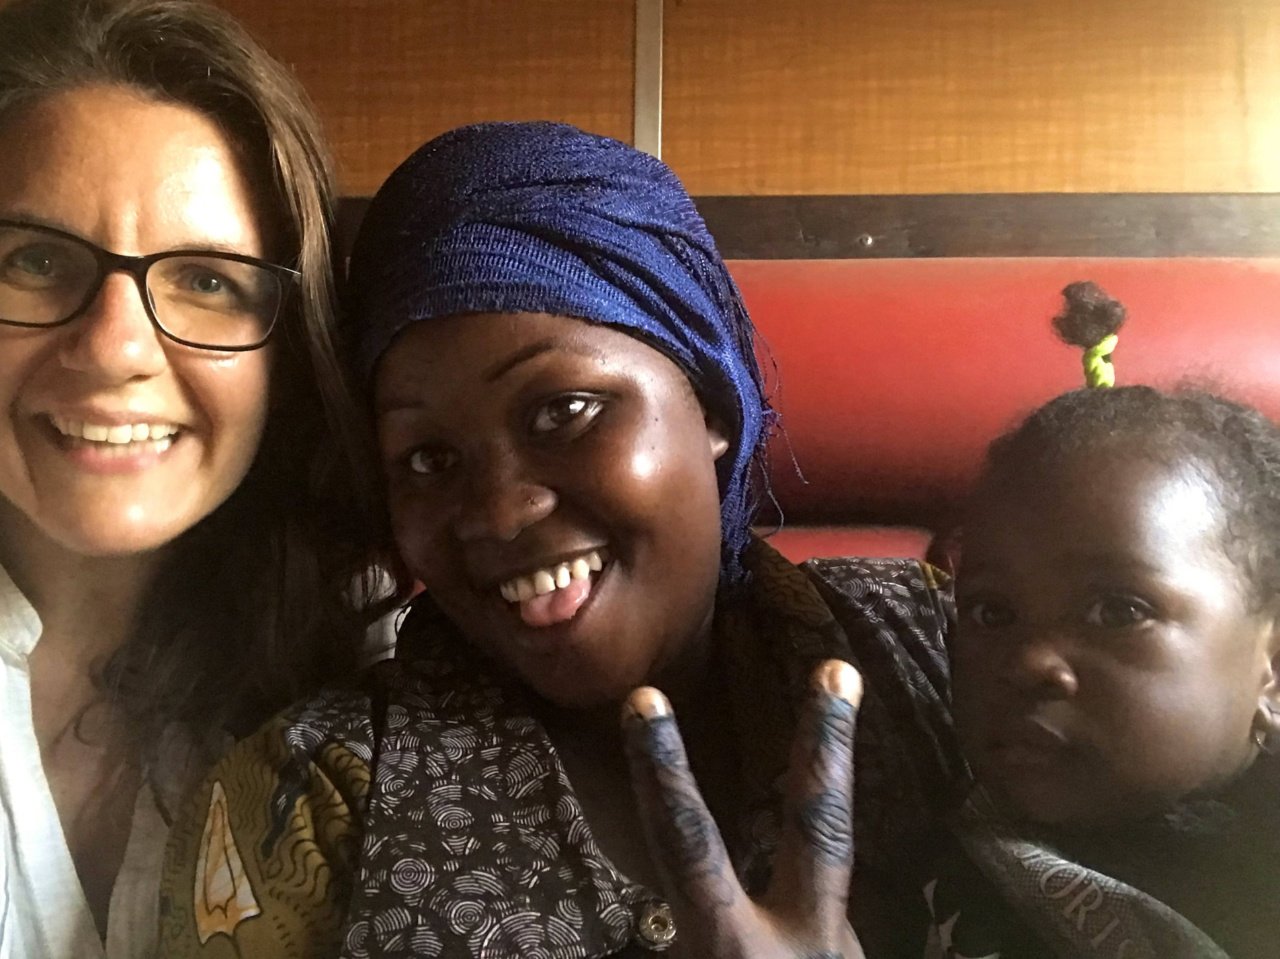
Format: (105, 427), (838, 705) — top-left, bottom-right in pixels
(161, 543), (960, 959)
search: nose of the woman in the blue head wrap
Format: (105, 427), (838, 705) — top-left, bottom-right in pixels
(453, 452), (557, 543)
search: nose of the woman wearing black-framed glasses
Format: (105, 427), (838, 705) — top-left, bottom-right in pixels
(58, 273), (169, 384)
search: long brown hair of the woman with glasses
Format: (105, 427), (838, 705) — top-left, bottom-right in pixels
(0, 0), (401, 741)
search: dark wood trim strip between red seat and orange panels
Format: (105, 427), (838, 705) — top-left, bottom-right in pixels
(338, 193), (1280, 260)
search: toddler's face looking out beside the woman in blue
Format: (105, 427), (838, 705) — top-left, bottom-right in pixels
(952, 455), (1275, 826)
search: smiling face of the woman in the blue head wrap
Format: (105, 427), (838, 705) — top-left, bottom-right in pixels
(376, 314), (728, 707)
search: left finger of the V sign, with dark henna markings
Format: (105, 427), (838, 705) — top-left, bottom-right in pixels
(622, 686), (746, 922)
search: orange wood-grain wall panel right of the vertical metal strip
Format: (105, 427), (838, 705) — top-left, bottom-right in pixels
(664, 0), (1280, 193)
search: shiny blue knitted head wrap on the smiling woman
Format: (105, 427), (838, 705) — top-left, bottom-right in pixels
(351, 123), (773, 581)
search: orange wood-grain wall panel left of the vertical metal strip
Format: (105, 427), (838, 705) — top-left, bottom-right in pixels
(218, 0), (635, 195)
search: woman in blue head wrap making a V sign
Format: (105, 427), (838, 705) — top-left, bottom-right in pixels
(163, 123), (957, 959)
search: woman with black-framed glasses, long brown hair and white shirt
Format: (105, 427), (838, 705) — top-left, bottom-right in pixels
(0, 0), (394, 959)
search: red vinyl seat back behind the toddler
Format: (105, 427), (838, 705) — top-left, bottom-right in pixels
(730, 257), (1280, 560)
